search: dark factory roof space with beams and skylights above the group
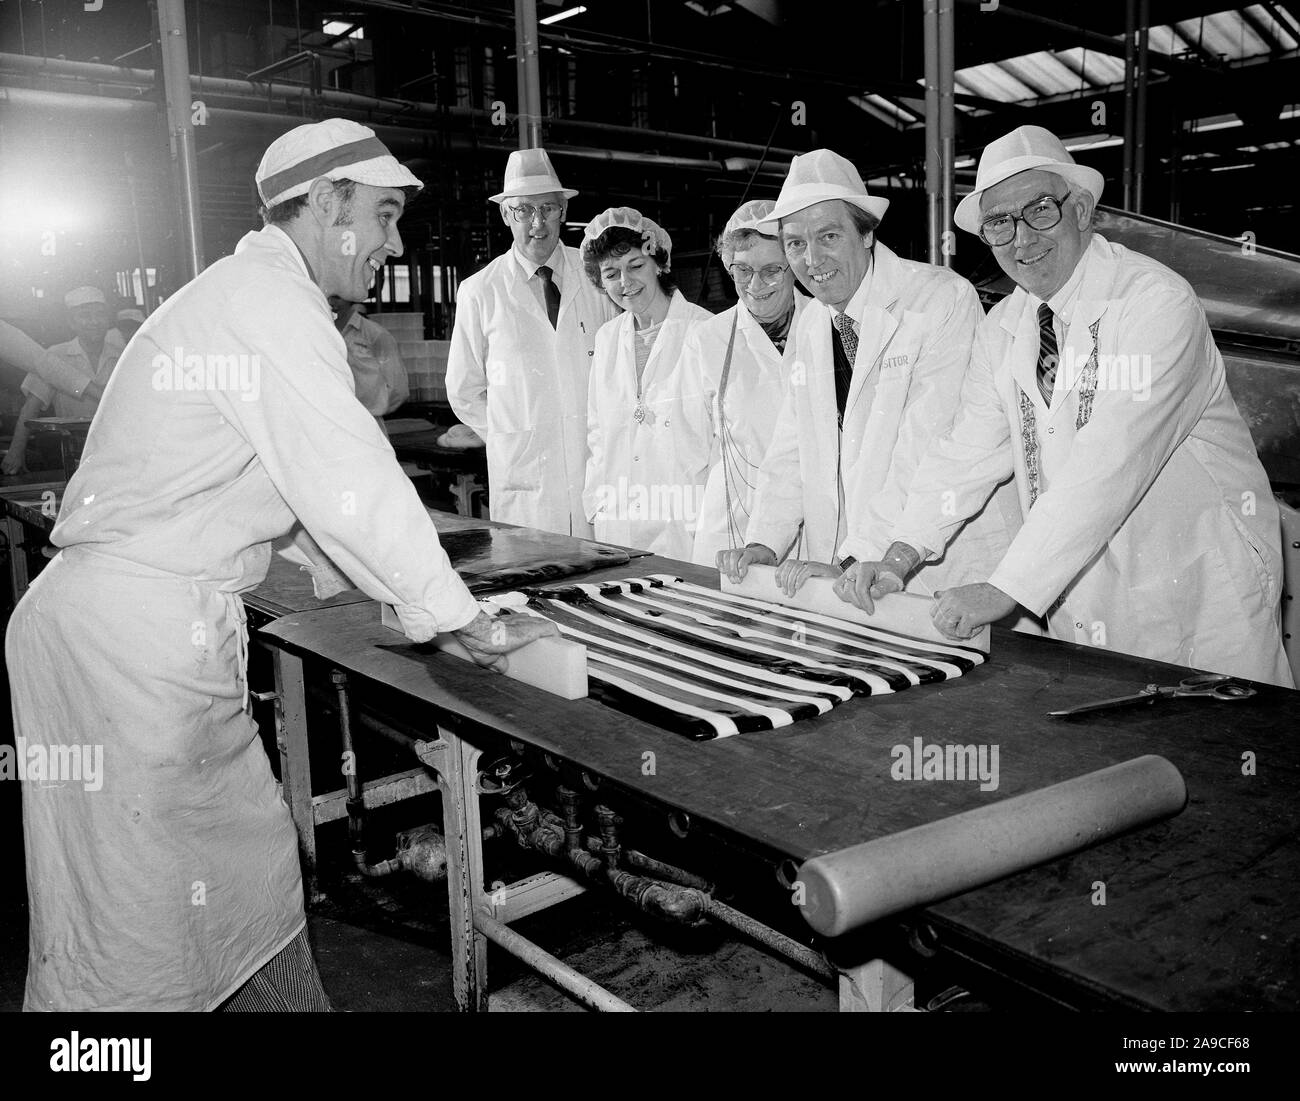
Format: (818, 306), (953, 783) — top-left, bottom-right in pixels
(0, 0), (1300, 304)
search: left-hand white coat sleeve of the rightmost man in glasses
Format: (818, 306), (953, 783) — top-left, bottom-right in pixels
(881, 317), (1015, 558)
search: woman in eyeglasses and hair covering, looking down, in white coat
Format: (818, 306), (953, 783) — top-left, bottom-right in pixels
(681, 199), (807, 565)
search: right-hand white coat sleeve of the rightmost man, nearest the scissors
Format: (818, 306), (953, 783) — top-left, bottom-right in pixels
(989, 281), (1225, 615)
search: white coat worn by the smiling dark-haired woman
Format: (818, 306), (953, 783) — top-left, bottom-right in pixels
(582, 291), (712, 562)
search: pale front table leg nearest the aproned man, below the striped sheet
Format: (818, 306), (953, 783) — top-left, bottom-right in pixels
(438, 727), (488, 1013)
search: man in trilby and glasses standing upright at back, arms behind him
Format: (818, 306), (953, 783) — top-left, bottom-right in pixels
(447, 149), (618, 537)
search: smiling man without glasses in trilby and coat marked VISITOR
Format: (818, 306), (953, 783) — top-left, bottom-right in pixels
(718, 149), (1019, 594)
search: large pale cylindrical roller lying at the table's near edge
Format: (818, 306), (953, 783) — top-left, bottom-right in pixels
(798, 757), (1187, 936)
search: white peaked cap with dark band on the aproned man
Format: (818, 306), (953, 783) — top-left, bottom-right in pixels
(257, 118), (424, 207)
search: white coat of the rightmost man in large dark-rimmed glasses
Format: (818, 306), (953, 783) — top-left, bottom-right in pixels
(893, 234), (1292, 686)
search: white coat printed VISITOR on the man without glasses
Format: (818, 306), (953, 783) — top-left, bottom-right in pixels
(745, 240), (1021, 593)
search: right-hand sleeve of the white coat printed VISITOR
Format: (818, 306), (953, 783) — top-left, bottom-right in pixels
(839, 278), (984, 559)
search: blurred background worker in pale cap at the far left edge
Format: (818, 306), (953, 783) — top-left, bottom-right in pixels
(0, 286), (122, 474)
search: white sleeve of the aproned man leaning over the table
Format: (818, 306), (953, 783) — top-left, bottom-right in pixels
(212, 278), (478, 642)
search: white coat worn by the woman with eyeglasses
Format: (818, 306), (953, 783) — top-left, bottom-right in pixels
(681, 291), (807, 565)
